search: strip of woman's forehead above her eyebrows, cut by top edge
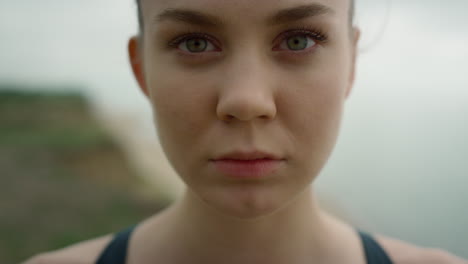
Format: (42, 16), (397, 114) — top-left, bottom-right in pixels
(141, 0), (351, 26)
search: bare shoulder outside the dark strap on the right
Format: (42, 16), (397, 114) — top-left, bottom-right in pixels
(375, 235), (468, 264)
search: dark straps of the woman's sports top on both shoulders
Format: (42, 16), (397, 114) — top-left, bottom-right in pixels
(96, 226), (393, 264)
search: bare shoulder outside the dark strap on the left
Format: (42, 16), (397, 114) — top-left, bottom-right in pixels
(23, 235), (113, 264)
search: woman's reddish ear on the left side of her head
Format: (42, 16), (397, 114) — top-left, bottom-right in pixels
(127, 37), (149, 97)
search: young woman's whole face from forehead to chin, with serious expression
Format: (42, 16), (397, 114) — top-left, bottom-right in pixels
(129, 0), (358, 218)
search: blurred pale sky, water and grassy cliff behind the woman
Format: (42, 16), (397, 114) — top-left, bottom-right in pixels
(0, 0), (468, 263)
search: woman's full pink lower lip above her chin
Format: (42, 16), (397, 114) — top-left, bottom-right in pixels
(213, 159), (283, 179)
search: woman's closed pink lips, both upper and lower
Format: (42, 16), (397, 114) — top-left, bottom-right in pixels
(210, 151), (285, 179)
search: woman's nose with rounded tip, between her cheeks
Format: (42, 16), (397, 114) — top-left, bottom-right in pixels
(216, 57), (277, 121)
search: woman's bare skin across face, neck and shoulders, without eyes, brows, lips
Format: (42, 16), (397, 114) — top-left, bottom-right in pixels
(22, 0), (465, 264)
